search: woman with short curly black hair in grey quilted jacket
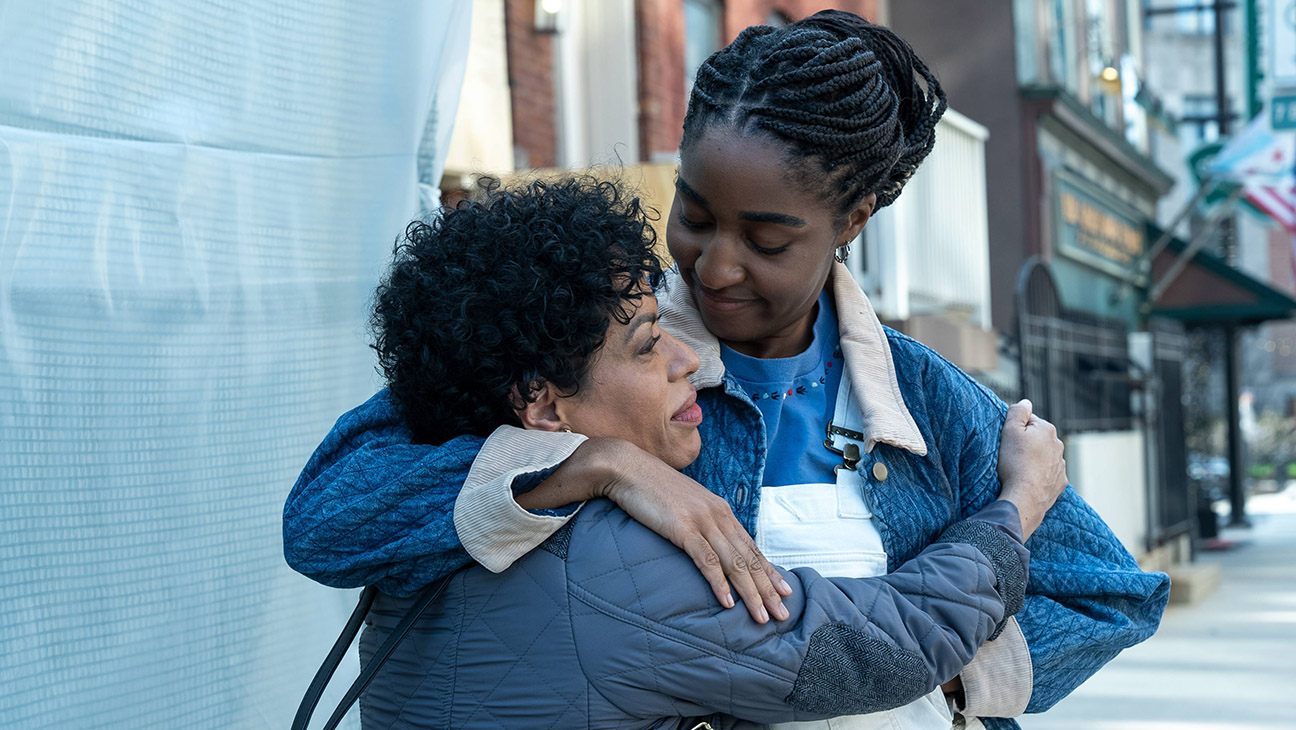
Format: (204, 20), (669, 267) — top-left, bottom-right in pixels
(334, 173), (1067, 729)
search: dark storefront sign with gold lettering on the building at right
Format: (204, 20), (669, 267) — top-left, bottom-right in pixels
(1054, 170), (1146, 280)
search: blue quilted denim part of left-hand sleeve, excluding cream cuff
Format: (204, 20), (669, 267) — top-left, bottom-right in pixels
(284, 390), (485, 596)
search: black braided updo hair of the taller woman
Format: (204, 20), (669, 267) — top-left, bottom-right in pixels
(680, 10), (946, 215)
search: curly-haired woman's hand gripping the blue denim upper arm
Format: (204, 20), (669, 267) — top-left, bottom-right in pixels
(999, 401), (1067, 539)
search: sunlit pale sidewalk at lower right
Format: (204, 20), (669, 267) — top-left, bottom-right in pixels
(1021, 488), (1296, 730)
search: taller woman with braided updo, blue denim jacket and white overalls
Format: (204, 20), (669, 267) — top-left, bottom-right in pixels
(285, 10), (1168, 730)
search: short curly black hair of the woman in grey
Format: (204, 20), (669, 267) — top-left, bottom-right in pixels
(371, 176), (662, 443)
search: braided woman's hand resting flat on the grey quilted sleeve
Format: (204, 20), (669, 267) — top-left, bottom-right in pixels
(573, 438), (792, 624)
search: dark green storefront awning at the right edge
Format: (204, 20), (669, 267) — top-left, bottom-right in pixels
(1147, 224), (1296, 324)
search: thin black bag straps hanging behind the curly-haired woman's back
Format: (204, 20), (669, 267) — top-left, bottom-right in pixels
(292, 573), (454, 730)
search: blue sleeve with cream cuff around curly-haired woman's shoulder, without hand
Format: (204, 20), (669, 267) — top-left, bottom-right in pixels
(283, 390), (593, 596)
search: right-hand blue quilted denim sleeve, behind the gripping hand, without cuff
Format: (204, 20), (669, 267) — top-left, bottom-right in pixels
(890, 333), (1170, 712)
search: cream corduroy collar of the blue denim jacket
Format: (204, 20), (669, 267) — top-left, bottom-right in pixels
(657, 263), (927, 456)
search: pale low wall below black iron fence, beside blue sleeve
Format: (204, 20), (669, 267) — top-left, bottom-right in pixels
(1067, 430), (1147, 556)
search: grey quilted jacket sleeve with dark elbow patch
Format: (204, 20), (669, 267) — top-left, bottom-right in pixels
(564, 502), (1029, 727)
